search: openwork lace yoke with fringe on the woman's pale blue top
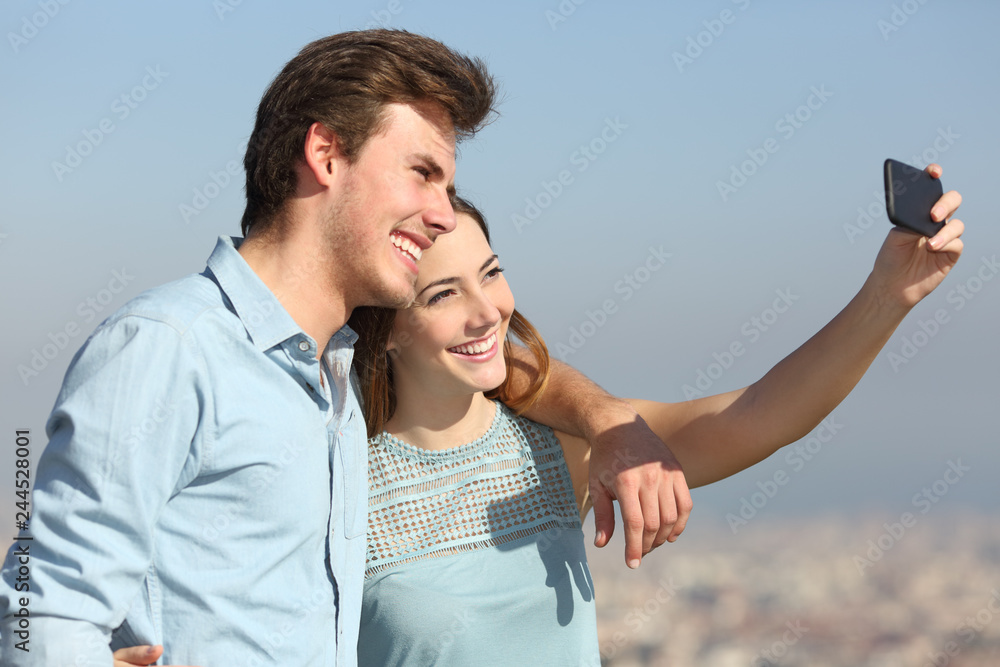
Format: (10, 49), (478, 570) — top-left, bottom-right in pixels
(365, 402), (580, 578)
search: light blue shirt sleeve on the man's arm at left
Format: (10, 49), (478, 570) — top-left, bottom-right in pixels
(0, 315), (205, 666)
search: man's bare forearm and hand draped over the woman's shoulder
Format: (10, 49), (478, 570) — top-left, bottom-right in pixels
(511, 346), (691, 568)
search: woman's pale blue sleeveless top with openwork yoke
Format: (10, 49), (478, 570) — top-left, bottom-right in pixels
(358, 402), (601, 667)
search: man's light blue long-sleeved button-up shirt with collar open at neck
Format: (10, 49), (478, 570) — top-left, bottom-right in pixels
(0, 237), (367, 667)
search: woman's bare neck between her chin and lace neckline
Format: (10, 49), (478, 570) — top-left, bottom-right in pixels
(385, 391), (496, 449)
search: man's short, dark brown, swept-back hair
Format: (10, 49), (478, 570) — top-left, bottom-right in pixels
(242, 28), (496, 236)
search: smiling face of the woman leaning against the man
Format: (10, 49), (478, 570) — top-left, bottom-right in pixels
(388, 214), (514, 396)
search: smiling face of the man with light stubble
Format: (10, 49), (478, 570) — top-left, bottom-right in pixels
(326, 103), (455, 308)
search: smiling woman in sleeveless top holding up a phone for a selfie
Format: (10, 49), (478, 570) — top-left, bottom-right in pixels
(117, 175), (963, 665)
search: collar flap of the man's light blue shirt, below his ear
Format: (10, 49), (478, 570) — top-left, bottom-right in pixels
(208, 236), (306, 351)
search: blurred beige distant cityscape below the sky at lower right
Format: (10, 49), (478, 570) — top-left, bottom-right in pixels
(588, 514), (1000, 667)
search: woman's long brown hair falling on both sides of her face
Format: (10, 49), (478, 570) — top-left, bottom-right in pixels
(348, 196), (549, 438)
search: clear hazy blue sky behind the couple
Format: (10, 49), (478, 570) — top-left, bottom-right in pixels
(0, 0), (1000, 543)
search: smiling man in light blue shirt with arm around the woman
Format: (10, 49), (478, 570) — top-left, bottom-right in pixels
(0, 30), (690, 666)
